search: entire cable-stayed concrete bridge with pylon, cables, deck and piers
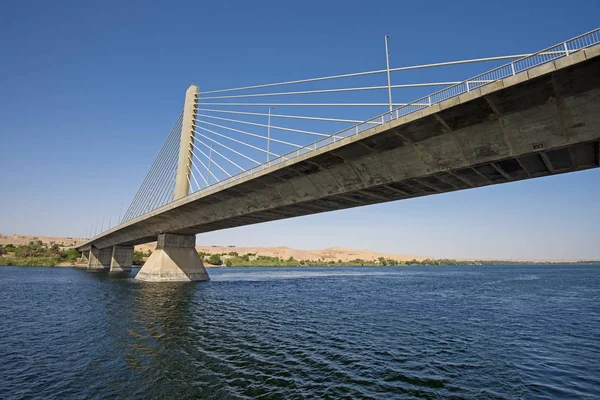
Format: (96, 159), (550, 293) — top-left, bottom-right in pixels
(78, 29), (600, 281)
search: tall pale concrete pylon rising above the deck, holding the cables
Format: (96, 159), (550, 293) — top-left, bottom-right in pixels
(173, 85), (200, 200)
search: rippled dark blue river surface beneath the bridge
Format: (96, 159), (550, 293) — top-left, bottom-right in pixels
(0, 265), (600, 399)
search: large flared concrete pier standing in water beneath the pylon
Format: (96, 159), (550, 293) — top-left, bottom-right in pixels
(135, 233), (210, 282)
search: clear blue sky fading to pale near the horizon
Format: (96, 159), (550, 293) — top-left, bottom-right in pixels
(0, 0), (600, 259)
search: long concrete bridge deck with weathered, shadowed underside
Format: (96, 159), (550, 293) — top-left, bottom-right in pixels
(81, 46), (600, 252)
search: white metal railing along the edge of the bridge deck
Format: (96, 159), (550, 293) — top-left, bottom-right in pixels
(184, 28), (600, 195)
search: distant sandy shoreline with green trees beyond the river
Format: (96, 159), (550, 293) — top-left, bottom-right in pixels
(0, 234), (600, 268)
